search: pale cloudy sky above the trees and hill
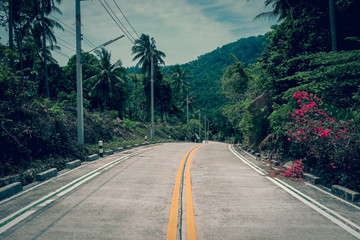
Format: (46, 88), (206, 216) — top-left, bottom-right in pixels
(0, 0), (275, 67)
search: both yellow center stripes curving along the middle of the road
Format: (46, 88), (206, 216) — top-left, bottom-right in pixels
(166, 145), (201, 240)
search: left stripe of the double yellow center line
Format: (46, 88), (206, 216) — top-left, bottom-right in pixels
(166, 145), (200, 240)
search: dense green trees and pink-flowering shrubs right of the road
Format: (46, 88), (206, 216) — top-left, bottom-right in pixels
(221, 0), (360, 190)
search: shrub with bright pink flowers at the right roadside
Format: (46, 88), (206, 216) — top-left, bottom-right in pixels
(285, 91), (360, 189)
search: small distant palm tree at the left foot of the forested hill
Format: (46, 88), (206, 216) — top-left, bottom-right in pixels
(171, 64), (191, 105)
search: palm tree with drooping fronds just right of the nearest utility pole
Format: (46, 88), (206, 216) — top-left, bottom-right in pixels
(85, 48), (125, 111)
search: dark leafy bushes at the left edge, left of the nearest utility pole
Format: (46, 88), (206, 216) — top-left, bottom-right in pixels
(0, 100), (82, 176)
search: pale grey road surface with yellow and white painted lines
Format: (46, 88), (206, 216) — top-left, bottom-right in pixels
(0, 142), (360, 240)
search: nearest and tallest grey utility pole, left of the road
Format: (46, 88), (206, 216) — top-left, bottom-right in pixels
(75, 0), (84, 146)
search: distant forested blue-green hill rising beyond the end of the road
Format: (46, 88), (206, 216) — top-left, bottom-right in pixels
(164, 36), (266, 113)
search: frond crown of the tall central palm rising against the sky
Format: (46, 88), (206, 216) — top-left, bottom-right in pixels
(132, 34), (166, 73)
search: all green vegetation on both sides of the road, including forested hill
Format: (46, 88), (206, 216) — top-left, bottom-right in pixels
(0, 0), (360, 190)
